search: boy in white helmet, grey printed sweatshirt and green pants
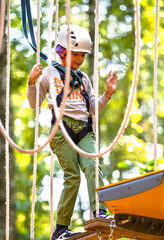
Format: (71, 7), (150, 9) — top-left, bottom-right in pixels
(27, 25), (118, 240)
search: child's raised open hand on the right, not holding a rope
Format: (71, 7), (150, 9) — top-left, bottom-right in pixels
(105, 71), (118, 98)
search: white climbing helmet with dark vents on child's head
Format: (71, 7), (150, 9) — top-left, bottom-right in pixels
(57, 24), (92, 53)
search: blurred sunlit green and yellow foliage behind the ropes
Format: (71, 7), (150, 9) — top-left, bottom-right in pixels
(6, 0), (164, 240)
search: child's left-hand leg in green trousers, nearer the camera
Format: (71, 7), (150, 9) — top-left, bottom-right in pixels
(50, 129), (80, 226)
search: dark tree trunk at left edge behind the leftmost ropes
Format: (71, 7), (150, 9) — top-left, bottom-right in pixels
(0, 1), (16, 240)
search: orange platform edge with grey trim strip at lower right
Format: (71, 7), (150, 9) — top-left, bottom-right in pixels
(97, 170), (164, 220)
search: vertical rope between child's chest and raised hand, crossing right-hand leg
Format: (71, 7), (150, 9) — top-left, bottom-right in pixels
(94, 0), (99, 215)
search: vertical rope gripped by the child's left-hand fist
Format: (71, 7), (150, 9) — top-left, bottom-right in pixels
(30, 0), (40, 240)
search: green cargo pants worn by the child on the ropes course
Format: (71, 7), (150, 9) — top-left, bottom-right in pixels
(50, 116), (106, 226)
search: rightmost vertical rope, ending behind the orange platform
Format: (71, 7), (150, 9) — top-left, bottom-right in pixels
(153, 0), (159, 170)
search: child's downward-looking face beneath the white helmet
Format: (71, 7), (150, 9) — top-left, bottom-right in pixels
(71, 52), (86, 71)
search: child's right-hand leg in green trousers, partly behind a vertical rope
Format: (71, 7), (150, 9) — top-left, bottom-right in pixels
(78, 132), (106, 212)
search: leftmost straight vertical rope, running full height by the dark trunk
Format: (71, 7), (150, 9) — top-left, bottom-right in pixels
(5, 0), (10, 240)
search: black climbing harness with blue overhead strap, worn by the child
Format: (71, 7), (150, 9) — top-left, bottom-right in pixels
(21, 0), (93, 143)
